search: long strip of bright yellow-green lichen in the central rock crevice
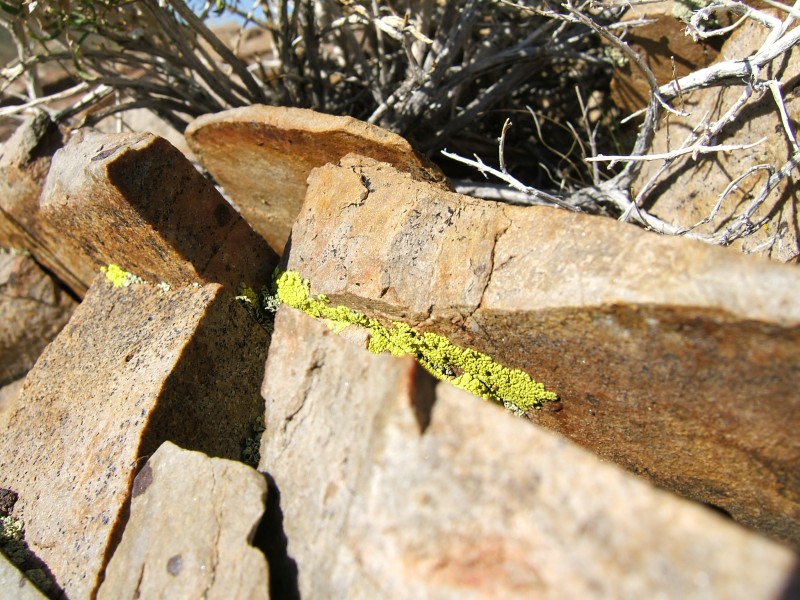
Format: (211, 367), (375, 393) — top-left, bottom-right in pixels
(275, 271), (558, 412)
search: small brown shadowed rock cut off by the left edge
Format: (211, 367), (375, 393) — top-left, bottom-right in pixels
(0, 252), (76, 386)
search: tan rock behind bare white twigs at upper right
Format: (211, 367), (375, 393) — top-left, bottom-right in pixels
(633, 11), (800, 262)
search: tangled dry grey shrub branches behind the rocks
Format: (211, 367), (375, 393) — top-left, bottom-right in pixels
(0, 0), (800, 253)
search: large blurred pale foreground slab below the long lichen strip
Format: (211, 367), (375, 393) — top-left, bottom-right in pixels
(259, 308), (797, 599)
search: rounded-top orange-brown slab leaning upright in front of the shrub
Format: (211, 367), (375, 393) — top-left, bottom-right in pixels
(186, 105), (446, 254)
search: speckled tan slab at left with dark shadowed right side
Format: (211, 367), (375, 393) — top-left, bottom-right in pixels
(0, 277), (267, 598)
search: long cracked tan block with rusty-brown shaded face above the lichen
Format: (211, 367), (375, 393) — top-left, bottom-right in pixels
(288, 157), (800, 547)
